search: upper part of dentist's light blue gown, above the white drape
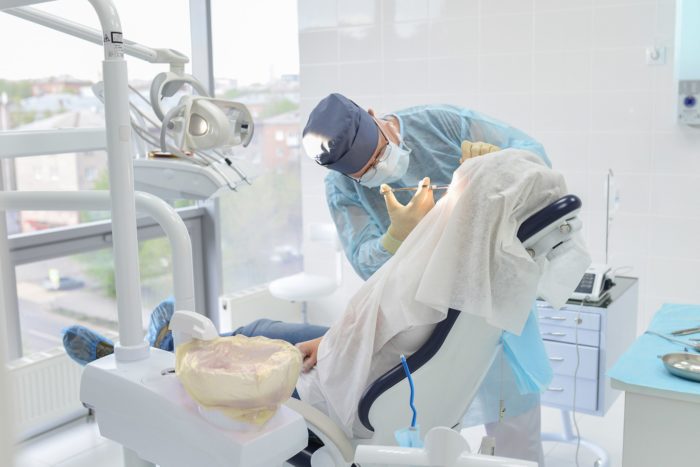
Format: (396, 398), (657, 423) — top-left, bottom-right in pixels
(326, 105), (550, 279)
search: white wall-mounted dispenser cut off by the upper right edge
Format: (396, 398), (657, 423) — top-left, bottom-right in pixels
(676, 0), (700, 127)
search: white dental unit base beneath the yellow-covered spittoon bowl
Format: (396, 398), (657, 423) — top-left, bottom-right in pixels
(80, 348), (308, 467)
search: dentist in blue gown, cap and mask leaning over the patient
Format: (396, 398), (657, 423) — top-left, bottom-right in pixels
(303, 94), (551, 465)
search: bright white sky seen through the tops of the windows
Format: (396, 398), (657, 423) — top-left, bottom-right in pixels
(0, 0), (299, 85)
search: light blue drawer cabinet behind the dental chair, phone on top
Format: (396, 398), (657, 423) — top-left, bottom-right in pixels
(537, 277), (639, 416)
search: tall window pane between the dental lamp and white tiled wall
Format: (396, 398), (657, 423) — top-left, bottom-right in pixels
(212, 0), (303, 292)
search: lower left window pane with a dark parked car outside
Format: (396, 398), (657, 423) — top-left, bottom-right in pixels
(15, 238), (173, 354)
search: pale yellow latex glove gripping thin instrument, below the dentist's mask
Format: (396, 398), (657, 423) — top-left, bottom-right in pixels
(380, 177), (435, 254)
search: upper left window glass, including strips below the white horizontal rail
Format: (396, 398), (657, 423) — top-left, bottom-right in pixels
(0, 0), (191, 234)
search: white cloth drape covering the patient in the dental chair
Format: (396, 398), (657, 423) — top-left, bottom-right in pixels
(297, 149), (589, 435)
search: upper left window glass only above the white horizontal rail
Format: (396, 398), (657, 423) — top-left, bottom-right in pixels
(0, 0), (191, 130)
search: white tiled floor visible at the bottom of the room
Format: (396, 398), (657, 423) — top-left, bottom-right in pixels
(15, 395), (624, 467)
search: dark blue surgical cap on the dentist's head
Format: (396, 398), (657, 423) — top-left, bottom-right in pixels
(303, 93), (379, 174)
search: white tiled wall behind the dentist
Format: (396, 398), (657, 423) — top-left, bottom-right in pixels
(299, 0), (700, 328)
